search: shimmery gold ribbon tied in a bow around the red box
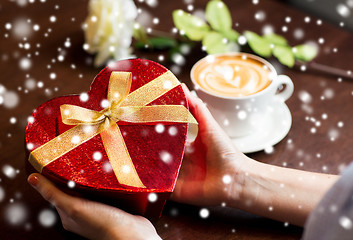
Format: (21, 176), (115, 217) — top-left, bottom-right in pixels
(28, 71), (197, 188)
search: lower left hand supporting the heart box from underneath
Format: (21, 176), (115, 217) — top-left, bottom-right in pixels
(28, 173), (161, 240)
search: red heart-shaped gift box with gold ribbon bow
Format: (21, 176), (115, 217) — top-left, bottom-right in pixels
(26, 59), (196, 217)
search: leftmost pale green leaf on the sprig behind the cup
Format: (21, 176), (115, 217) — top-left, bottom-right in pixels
(173, 9), (210, 41)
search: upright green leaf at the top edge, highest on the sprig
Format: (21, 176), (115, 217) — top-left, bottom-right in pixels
(206, 0), (232, 32)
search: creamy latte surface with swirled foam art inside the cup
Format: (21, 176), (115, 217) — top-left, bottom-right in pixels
(193, 55), (271, 97)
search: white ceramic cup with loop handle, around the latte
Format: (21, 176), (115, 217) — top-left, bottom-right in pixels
(191, 53), (294, 137)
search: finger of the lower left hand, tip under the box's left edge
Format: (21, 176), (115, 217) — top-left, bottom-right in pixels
(27, 173), (75, 210)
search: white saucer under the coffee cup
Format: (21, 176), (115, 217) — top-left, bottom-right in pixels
(232, 102), (292, 153)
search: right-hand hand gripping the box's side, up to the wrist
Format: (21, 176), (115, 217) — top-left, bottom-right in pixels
(172, 84), (253, 205)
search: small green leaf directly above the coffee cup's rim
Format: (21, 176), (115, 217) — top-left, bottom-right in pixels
(202, 32), (227, 54)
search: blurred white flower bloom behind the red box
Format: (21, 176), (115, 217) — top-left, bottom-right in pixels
(84, 0), (137, 66)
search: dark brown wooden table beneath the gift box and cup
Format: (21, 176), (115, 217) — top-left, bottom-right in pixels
(0, 0), (353, 240)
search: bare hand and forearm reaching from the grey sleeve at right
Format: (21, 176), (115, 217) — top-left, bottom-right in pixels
(172, 85), (338, 226)
